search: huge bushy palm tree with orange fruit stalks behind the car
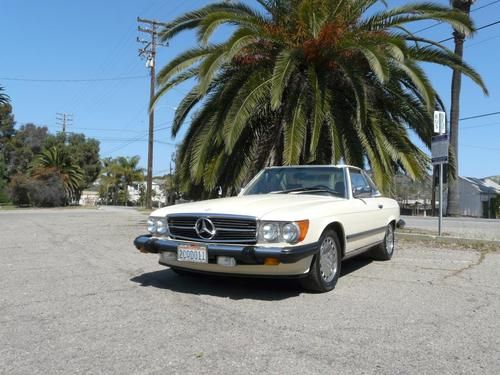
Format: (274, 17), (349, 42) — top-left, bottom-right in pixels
(152, 0), (486, 197)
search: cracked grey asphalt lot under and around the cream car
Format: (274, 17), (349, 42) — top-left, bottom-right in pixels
(0, 209), (500, 375)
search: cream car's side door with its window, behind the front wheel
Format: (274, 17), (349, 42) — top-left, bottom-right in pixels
(345, 168), (386, 252)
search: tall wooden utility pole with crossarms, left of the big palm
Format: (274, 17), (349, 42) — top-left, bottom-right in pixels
(137, 17), (168, 208)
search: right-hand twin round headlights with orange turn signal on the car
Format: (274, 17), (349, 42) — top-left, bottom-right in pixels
(259, 220), (309, 243)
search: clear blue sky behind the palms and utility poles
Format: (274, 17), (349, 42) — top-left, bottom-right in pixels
(0, 0), (500, 177)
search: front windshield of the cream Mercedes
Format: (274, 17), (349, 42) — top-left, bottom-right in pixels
(243, 167), (345, 197)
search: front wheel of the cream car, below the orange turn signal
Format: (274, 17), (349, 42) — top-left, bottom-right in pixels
(301, 229), (341, 293)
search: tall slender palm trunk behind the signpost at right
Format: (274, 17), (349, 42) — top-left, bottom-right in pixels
(446, 0), (475, 216)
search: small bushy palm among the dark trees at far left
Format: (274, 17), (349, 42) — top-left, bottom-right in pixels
(30, 146), (83, 200)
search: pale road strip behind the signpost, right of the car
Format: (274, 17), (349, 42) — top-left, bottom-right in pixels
(401, 216), (500, 241)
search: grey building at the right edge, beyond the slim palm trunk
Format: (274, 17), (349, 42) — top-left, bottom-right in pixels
(458, 177), (500, 219)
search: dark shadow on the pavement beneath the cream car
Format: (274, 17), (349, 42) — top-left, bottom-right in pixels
(130, 257), (371, 301)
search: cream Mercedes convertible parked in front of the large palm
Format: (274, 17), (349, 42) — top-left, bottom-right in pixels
(134, 166), (399, 292)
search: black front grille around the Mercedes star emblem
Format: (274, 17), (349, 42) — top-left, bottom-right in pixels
(167, 214), (257, 244)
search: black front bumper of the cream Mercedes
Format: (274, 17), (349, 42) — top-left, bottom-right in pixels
(134, 235), (318, 265)
